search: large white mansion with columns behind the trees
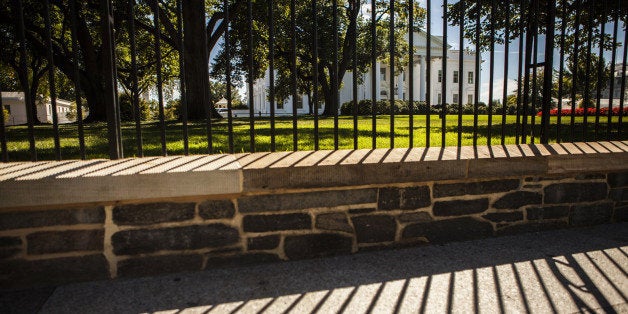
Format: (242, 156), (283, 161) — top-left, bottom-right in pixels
(253, 31), (479, 115)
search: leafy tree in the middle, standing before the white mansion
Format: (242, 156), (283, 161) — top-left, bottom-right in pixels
(213, 0), (425, 115)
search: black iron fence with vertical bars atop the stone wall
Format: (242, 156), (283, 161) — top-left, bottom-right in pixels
(0, 0), (628, 162)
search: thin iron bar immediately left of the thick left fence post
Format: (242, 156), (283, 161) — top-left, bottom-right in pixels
(70, 0), (85, 160)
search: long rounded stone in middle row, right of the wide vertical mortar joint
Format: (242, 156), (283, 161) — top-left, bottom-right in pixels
(111, 224), (240, 255)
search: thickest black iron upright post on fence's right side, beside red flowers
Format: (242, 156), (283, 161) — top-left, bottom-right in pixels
(540, 1), (556, 144)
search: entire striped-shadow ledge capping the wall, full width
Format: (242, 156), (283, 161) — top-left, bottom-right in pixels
(0, 141), (628, 209)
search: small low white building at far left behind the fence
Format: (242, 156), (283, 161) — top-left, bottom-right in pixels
(2, 92), (74, 125)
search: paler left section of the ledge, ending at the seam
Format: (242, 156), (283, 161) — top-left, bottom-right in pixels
(0, 155), (241, 209)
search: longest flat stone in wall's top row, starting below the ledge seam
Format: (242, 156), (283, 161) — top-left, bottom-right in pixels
(238, 189), (377, 213)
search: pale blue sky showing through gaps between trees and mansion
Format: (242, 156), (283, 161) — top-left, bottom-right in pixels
(205, 0), (624, 103)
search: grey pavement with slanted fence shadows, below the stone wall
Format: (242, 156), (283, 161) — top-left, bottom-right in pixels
(0, 223), (628, 313)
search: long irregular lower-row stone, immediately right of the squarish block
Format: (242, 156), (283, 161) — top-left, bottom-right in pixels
(402, 217), (493, 243)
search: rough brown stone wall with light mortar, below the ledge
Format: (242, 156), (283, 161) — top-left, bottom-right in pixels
(0, 142), (628, 289)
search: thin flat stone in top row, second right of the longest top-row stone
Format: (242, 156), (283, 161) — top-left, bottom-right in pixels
(434, 179), (519, 198)
